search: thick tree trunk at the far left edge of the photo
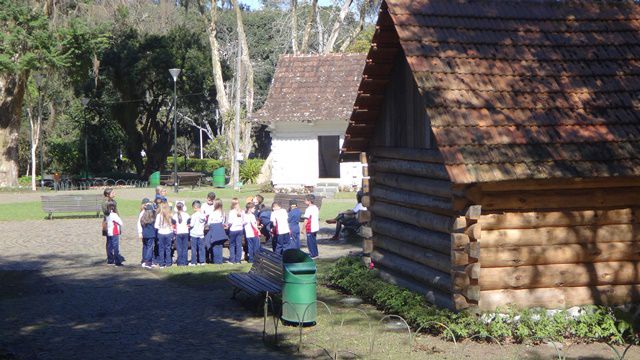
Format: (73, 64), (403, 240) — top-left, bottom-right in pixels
(0, 72), (29, 187)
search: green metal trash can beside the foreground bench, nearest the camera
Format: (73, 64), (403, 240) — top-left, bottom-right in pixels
(282, 249), (317, 326)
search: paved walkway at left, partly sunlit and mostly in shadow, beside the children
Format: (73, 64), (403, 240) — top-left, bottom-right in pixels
(0, 218), (355, 360)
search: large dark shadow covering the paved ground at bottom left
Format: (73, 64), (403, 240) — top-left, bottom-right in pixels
(0, 255), (293, 360)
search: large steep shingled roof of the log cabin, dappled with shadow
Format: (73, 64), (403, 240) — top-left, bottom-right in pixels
(343, 0), (640, 183)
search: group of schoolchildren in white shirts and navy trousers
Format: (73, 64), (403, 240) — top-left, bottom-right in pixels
(103, 187), (320, 268)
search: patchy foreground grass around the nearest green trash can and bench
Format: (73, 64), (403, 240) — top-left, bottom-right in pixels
(157, 259), (425, 359)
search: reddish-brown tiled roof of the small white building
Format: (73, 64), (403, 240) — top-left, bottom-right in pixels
(253, 54), (366, 123)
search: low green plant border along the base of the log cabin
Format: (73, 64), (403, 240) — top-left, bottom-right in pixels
(328, 257), (638, 344)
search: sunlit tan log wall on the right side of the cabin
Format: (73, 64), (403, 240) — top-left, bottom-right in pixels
(478, 207), (640, 311)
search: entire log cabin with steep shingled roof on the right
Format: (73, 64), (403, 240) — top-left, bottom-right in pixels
(341, 0), (640, 311)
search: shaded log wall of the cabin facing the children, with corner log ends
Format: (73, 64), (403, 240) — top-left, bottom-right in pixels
(361, 147), (481, 310)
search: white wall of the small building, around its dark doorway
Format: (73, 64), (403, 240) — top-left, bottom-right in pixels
(269, 121), (362, 187)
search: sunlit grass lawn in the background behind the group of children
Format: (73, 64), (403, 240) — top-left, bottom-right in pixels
(0, 185), (355, 221)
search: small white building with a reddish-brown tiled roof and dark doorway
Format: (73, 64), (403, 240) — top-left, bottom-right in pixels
(254, 54), (366, 188)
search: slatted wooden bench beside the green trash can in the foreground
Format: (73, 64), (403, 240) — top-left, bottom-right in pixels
(227, 248), (282, 298)
